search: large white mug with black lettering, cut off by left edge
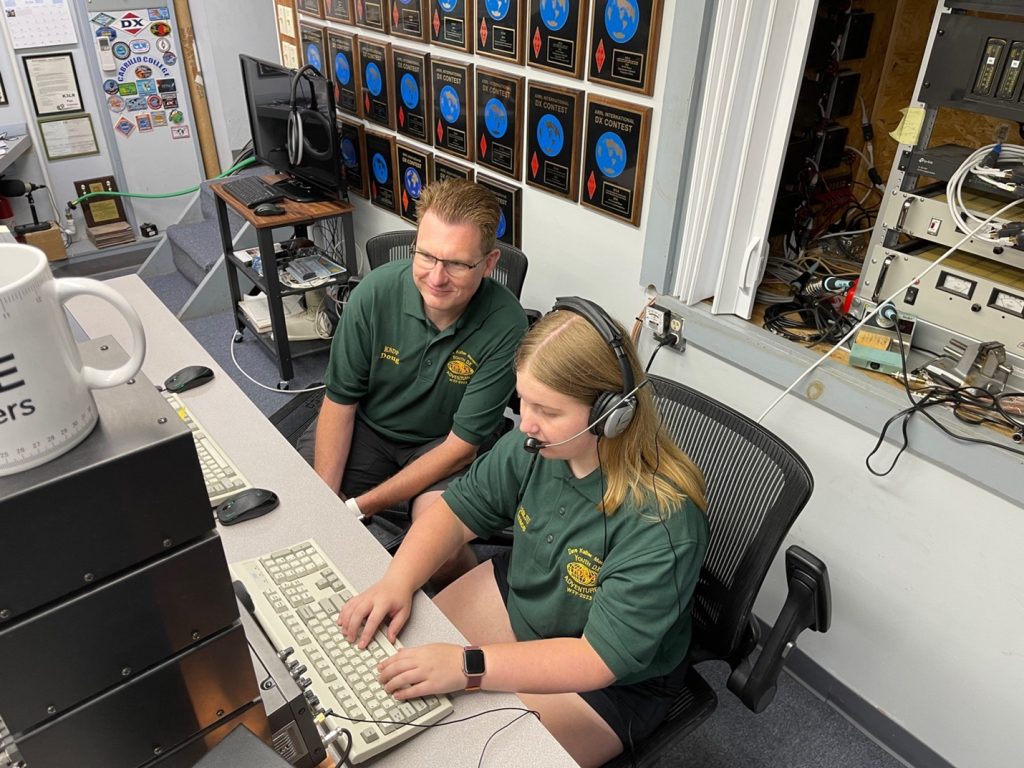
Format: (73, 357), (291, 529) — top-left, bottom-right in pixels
(0, 243), (145, 475)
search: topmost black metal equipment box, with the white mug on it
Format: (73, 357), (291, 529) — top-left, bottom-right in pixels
(0, 337), (214, 631)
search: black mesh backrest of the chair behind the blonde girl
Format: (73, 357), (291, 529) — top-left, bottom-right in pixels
(649, 375), (814, 662)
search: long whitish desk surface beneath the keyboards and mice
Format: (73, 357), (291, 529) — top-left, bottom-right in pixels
(68, 275), (575, 768)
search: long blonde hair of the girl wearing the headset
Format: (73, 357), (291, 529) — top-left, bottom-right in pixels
(515, 309), (707, 518)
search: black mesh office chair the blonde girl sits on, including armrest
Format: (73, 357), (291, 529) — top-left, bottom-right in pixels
(608, 376), (831, 768)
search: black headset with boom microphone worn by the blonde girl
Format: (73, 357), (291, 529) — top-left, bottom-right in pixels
(522, 296), (647, 454)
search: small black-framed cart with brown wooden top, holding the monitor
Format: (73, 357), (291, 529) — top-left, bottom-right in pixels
(210, 176), (357, 389)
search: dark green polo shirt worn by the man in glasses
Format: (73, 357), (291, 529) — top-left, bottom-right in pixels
(325, 260), (526, 445)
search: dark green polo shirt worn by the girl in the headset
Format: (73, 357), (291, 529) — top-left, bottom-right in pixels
(444, 433), (708, 683)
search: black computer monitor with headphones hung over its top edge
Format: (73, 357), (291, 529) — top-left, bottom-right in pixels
(239, 53), (348, 201)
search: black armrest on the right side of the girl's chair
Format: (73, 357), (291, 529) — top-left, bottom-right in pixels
(728, 546), (831, 712)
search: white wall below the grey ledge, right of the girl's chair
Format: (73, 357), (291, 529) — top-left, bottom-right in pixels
(647, 342), (1024, 768)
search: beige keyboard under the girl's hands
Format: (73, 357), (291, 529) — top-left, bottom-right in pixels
(228, 540), (454, 765)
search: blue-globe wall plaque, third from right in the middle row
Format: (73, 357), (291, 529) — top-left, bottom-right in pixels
(475, 68), (523, 180)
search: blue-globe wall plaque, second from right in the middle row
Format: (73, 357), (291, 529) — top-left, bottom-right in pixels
(526, 83), (584, 202)
